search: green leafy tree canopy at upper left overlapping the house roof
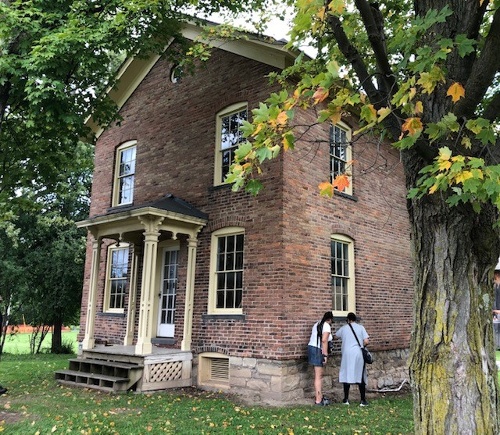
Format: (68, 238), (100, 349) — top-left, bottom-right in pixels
(0, 0), (272, 216)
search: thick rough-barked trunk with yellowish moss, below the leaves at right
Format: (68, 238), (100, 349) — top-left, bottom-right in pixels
(409, 193), (500, 435)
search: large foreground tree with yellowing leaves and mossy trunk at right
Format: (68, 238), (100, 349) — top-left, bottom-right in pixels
(224, 0), (500, 434)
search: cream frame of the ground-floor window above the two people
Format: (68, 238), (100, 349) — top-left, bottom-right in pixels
(330, 234), (356, 317)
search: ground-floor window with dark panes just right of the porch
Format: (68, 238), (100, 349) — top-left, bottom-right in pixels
(209, 227), (245, 314)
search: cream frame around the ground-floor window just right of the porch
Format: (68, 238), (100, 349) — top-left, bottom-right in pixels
(208, 227), (245, 314)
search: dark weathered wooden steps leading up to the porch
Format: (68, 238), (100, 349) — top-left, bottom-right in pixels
(55, 358), (144, 392)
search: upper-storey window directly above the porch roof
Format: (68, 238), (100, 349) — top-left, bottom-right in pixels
(113, 141), (137, 206)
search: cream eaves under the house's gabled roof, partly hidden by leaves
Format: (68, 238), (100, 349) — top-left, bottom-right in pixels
(87, 23), (297, 137)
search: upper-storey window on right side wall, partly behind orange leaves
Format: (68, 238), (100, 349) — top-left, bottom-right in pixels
(330, 125), (352, 195)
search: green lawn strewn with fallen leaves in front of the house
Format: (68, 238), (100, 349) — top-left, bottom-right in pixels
(0, 354), (413, 435)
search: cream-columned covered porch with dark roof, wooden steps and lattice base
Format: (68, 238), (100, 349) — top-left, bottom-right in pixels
(56, 195), (207, 391)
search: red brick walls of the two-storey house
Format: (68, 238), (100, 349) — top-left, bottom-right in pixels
(78, 43), (412, 359)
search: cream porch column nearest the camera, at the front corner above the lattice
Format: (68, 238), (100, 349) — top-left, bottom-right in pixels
(135, 218), (163, 355)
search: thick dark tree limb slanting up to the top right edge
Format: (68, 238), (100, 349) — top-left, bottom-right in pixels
(454, 8), (500, 118)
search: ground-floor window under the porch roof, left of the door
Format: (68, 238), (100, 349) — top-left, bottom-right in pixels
(104, 243), (129, 313)
